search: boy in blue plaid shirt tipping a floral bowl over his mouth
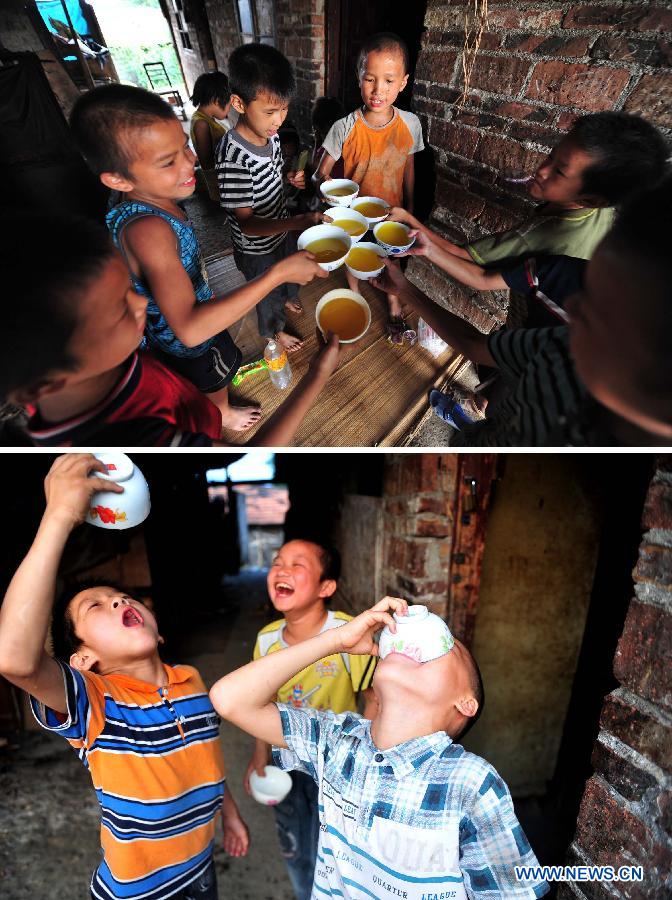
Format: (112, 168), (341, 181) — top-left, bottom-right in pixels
(210, 597), (548, 900)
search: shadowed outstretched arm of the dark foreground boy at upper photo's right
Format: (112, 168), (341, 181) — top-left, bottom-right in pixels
(371, 259), (497, 367)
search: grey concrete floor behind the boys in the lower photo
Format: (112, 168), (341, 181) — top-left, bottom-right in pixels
(0, 572), (294, 900)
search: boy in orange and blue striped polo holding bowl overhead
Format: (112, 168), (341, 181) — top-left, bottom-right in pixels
(0, 454), (249, 900)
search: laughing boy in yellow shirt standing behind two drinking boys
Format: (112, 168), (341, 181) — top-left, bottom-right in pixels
(245, 540), (375, 900)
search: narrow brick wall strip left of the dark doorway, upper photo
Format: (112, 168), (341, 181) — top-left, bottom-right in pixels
(275, 0), (325, 141)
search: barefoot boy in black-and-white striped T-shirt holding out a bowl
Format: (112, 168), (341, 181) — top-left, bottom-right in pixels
(215, 44), (322, 353)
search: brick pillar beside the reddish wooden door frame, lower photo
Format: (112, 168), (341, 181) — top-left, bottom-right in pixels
(383, 453), (459, 624)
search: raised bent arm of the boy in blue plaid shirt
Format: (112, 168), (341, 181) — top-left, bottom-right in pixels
(210, 597), (407, 748)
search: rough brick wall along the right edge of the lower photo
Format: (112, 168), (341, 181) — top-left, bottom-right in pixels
(558, 457), (672, 900)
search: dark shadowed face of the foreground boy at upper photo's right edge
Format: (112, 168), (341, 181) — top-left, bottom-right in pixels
(566, 237), (672, 438)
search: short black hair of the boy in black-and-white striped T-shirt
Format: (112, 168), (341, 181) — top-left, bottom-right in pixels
(229, 44), (296, 103)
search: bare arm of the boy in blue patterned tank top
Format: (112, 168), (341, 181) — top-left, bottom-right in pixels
(124, 216), (329, 347)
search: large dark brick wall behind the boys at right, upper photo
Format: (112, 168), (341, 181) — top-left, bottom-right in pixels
(409, 0), (672, 331)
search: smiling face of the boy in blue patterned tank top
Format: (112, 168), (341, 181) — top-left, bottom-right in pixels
(101, 118), (196, 201)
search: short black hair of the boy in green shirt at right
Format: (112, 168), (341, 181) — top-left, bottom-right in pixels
(567, 112), (670, 206)
